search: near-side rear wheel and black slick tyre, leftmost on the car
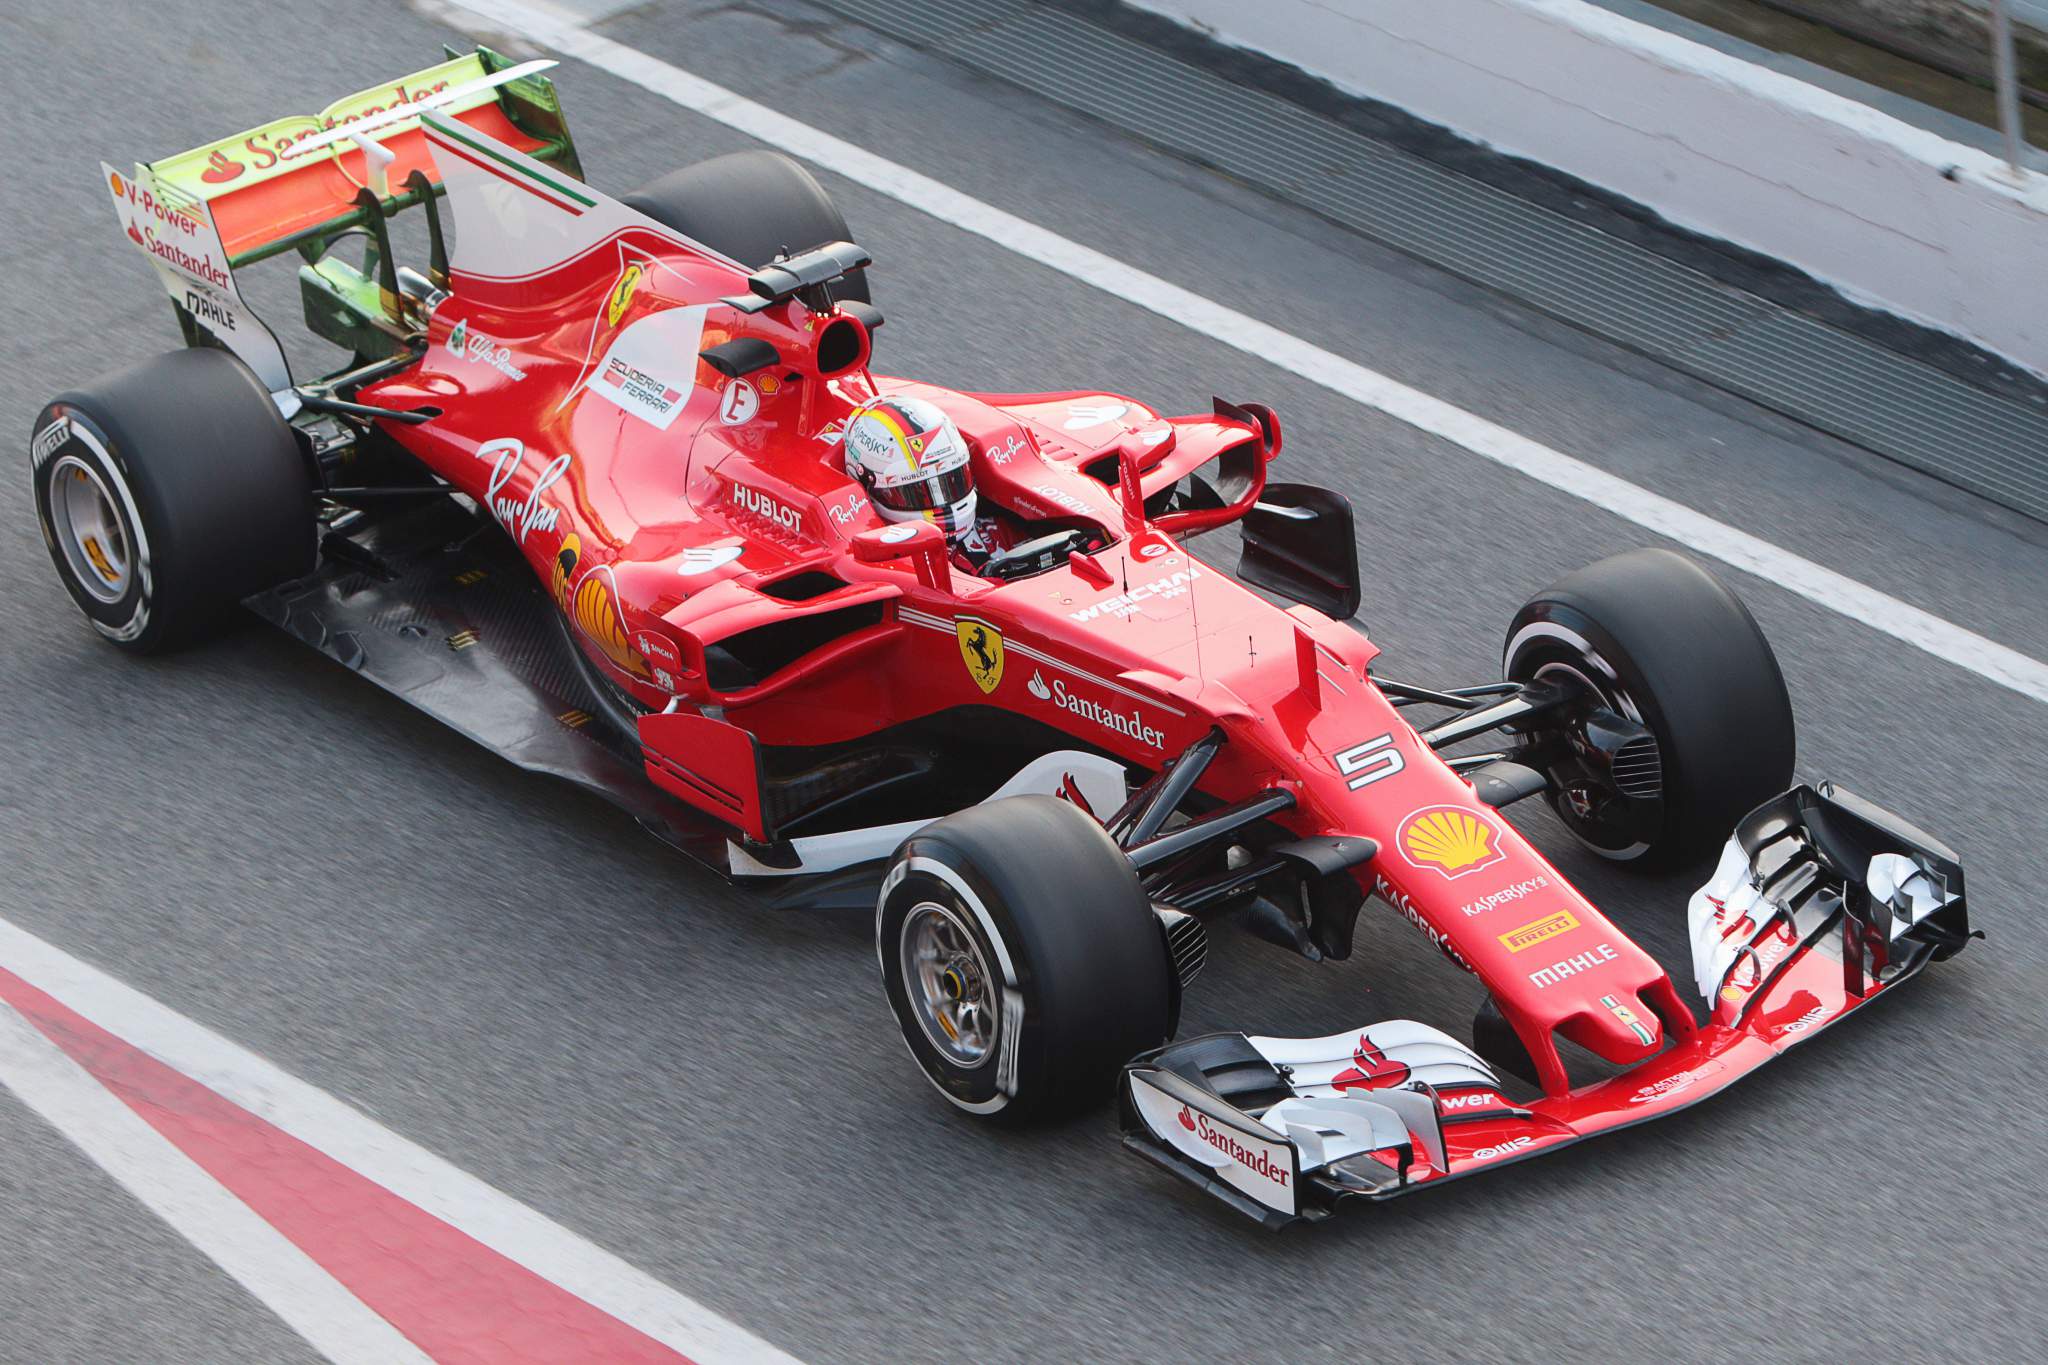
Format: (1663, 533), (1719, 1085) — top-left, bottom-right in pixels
(29, 350), (315, 653)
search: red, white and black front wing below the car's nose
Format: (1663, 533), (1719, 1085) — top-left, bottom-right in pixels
(1118, 784), (1976, 1228)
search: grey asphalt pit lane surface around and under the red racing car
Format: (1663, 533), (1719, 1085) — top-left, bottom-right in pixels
(0, 0), (2048, 1361)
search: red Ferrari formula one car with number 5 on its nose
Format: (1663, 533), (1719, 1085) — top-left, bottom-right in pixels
(33, 51), (1970, 1224)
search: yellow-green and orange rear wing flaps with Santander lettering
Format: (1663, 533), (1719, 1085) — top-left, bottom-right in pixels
(147, 47), (582, 266)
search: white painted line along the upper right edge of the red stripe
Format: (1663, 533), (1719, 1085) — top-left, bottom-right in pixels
(0, 919), (797, 1365)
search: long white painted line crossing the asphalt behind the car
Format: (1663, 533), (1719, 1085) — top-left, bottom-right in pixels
(436, 0), (2048, 716)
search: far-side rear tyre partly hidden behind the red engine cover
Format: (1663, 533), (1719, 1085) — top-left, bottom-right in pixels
(625, 151), (868, 303)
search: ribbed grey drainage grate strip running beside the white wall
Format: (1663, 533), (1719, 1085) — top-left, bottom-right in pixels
(817, 0), (2048, 522)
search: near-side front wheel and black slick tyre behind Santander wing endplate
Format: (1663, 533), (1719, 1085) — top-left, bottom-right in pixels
(874, 796), (1171, 1124)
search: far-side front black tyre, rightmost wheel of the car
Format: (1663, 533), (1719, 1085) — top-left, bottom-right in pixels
(1503, 548), (1796, 866)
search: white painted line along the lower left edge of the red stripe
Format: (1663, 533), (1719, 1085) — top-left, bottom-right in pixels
(0, 1003), (428, 1365)
